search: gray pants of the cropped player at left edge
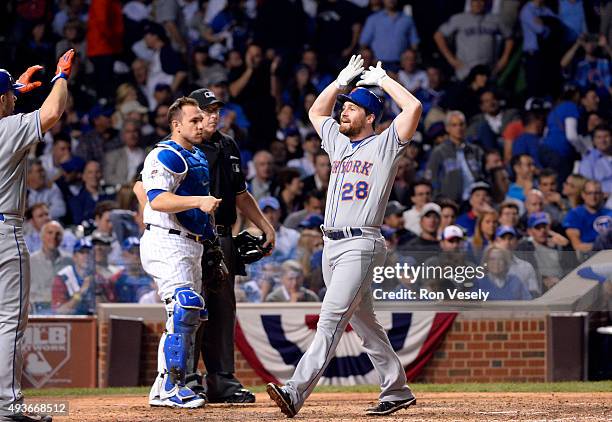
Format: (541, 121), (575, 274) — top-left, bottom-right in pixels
(0, 222), (29, 420)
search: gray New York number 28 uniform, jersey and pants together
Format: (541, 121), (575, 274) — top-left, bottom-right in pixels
(283, 114), (414, 411)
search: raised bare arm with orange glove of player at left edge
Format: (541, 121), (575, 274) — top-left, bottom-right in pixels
(40, 49), (74, 132)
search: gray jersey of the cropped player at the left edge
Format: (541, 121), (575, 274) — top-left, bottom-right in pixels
(0, 110), (42, 217)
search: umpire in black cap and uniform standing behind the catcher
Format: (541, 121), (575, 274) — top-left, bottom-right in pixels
(188, 89), (275, 403)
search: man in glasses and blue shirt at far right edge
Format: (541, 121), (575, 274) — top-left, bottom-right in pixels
(563, 180), (612, 252)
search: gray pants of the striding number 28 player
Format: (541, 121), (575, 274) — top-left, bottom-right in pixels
(284, 235), (413, 411)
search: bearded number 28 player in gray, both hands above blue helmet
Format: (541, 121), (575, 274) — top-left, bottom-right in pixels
(267, 56), (421, 417)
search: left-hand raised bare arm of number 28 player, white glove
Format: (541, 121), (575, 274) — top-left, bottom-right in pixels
(308, 55), (363, 137)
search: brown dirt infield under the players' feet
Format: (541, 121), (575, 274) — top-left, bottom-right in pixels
(44, 392), (612, 422)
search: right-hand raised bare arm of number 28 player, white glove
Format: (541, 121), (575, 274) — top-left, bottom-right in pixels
(357, 62), (423, 141)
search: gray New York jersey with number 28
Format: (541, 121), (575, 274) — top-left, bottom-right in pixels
(321, 117), (408, 228)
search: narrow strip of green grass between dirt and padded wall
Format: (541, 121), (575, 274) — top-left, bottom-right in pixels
(25, 381), (612, 397)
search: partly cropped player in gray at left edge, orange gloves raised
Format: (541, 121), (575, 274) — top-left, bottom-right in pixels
(0, 50), (74, 421)
